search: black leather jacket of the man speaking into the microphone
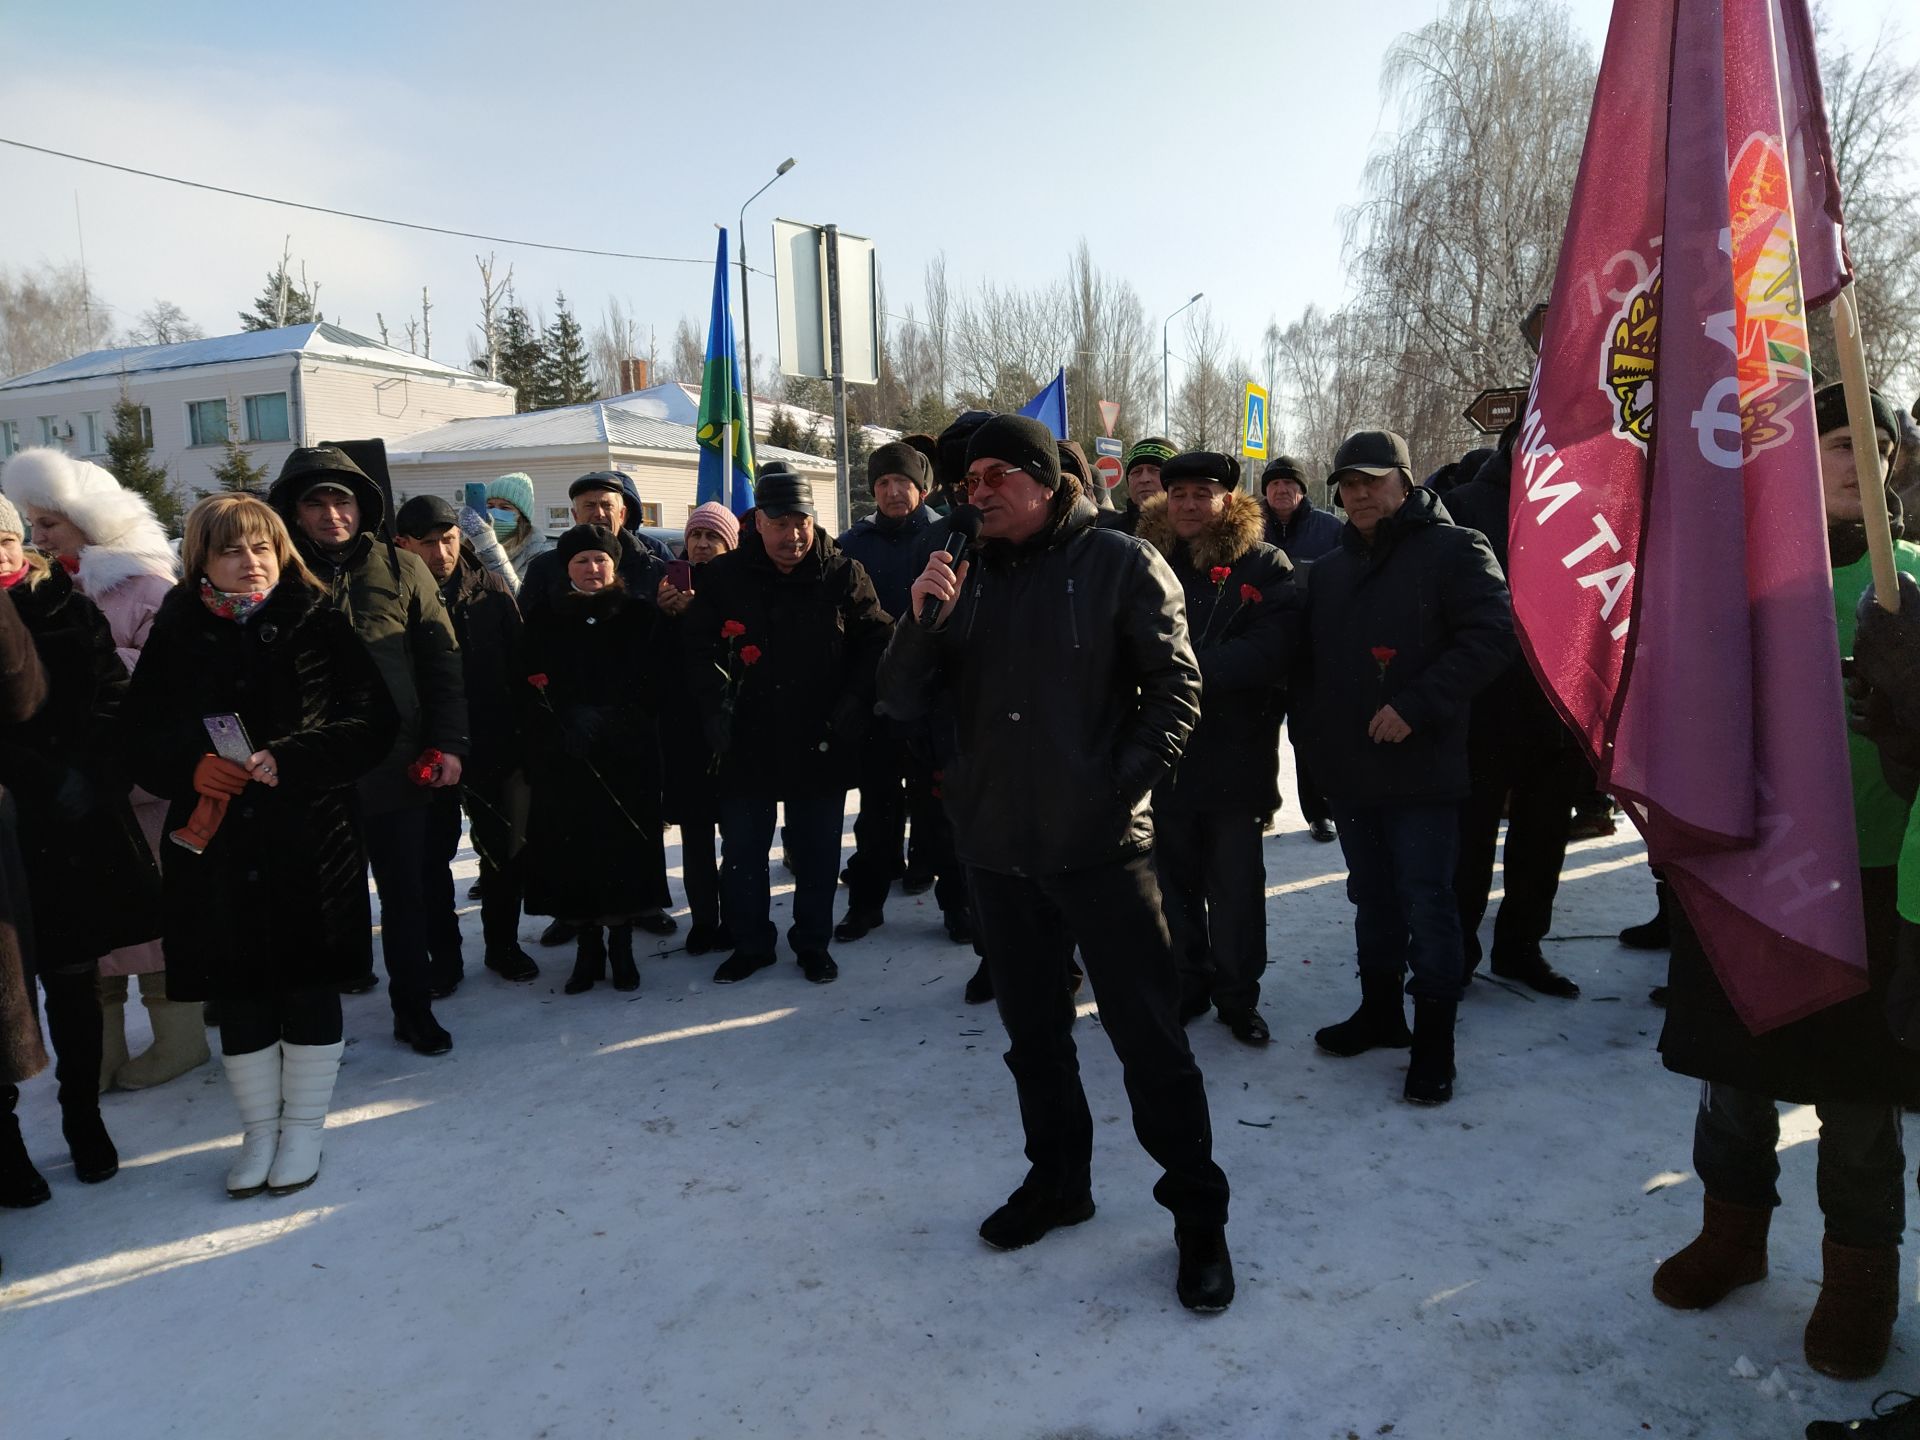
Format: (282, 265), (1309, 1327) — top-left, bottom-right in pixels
(879, 492), (1200, 876)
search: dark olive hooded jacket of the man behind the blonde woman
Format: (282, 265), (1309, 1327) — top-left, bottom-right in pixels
(267, 472), (470, 818)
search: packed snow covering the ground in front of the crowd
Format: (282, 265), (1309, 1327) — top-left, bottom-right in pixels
(0, 766), (1920, 1440)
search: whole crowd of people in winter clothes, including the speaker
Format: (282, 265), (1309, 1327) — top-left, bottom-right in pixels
(0, 388), (1920, 1420)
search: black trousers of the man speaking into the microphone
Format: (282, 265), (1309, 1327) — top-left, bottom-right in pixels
(968, 854), (1227, 1225)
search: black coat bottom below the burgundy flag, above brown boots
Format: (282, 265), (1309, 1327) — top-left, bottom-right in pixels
(1661, 866), (1920, 1106)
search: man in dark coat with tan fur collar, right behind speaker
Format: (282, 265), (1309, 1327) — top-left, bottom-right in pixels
(1135, 451), (1300, 1044)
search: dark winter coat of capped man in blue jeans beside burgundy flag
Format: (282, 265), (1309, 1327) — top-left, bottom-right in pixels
(1292, 490), (1515, 808)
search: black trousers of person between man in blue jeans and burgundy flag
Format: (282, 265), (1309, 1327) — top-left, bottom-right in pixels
(1453, 733), (1592, 975)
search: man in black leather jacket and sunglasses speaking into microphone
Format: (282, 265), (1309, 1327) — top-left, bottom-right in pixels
(879, 415), (1233, 1311)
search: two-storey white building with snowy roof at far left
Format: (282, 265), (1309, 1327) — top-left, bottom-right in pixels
(0, 323), (513, 501)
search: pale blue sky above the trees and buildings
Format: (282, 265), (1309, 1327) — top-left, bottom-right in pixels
(0, 0), (1920, 407)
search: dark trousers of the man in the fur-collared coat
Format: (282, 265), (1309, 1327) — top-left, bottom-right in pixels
(1154, 806), (1267, 1014)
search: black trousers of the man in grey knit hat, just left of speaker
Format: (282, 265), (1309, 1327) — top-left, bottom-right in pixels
(847, 724), (966, 914)
